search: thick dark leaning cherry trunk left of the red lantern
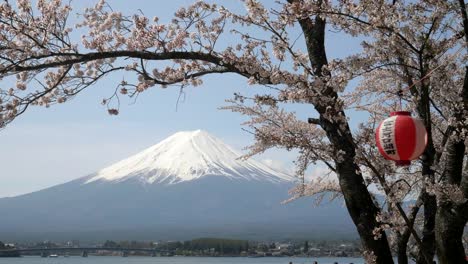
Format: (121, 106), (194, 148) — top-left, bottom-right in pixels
(288, 0), (393, 264)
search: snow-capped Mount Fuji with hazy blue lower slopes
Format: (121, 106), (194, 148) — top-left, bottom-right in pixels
(0, 130), (356, 241)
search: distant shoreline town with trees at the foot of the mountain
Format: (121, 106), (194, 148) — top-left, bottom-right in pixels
(0, 238), (361, 257)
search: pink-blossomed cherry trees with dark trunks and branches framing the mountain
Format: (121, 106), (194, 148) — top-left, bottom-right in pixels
(0, 0), (468, 263)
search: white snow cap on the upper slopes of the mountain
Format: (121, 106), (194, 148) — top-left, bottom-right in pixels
(85, 130), (294, 184)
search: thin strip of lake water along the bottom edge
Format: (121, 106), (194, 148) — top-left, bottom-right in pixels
(0, 256), (364, 264)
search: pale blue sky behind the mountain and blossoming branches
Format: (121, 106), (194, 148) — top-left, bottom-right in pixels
(0, 0), (359, 197)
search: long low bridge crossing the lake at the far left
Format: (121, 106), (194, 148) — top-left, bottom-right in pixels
(0, 247), (172, 257)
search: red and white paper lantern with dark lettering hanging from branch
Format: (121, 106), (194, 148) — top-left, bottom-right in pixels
(375, 111), (427, 166)
